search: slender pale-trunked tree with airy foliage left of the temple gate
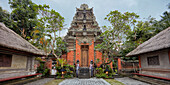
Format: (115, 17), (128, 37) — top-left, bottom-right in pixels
(38, 5), (64, 58)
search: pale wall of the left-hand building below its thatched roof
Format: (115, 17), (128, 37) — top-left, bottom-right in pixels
(0, 55), (36, 79)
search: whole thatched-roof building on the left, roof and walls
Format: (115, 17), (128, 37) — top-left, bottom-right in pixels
(0, 23), (45, 79)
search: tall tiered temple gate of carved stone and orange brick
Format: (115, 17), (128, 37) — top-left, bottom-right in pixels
(64, 4), (102, 67)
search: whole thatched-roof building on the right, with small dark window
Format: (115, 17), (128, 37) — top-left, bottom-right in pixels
(126, 27), (170, 80)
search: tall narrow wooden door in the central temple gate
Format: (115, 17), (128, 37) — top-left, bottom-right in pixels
(81, 45), (88, 67)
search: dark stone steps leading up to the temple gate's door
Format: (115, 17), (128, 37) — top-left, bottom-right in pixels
(78, 67), (90, 78)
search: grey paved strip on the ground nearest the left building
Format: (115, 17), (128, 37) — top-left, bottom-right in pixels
(24, 78), (54, 85)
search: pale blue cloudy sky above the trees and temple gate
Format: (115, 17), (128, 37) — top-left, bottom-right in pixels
(0, 0), (170, 36)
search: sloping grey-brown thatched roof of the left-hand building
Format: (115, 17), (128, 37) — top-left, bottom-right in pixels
(0, 23), (45, 55)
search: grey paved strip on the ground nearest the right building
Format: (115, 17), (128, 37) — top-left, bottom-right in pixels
(115, 77), (150, 85)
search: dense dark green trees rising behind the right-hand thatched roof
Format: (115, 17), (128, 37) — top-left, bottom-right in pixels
(120, 4), (170, 60)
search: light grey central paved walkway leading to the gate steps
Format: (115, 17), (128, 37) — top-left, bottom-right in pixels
(59, 78), (110, 85)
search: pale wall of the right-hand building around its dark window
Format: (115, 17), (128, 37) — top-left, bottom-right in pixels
(140, 49), (170, 78)
